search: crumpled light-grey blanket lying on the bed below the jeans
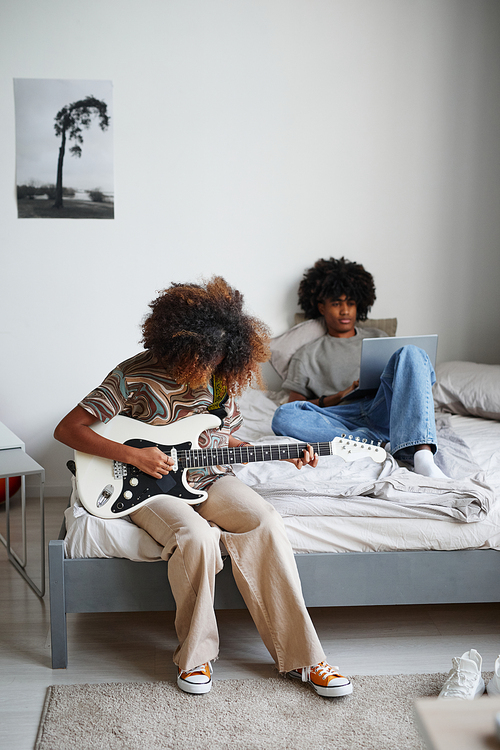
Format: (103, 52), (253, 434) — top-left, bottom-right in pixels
(233, 415), (495, 523)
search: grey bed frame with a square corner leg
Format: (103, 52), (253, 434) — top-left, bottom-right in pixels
(49, 530), (500, 669)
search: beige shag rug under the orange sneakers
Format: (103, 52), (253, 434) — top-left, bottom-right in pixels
(35, 674), (447, 750)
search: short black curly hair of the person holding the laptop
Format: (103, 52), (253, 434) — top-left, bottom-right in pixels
(299, 258), (376, 320)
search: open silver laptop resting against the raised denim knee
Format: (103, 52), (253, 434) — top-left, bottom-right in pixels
(342, 333), (438, 402)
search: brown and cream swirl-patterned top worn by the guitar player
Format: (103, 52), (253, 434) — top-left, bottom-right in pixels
(79, 351), (242, 490)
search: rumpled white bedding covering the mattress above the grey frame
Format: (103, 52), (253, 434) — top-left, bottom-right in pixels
(65, 390), (500, 561)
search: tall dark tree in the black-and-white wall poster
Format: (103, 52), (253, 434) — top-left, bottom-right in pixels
(54, 96), (109, 208)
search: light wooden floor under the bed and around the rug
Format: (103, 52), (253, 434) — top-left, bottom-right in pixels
(0, 498), (500, 750)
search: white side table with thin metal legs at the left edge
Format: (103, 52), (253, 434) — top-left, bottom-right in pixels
(0, 422), (45, 597)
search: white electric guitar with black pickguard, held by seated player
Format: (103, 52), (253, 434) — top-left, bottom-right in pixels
(75, 414), (386, 518)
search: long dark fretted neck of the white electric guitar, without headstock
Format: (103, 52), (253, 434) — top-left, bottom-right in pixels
(177, 443), (333, 469)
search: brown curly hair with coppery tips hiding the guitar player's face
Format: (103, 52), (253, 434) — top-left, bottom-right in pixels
(142, 276), (269, 393)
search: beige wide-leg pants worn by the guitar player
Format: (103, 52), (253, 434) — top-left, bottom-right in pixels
(130, 476), (325, 672)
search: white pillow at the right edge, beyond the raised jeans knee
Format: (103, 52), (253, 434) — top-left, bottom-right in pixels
(434, 362), (500, 420)
